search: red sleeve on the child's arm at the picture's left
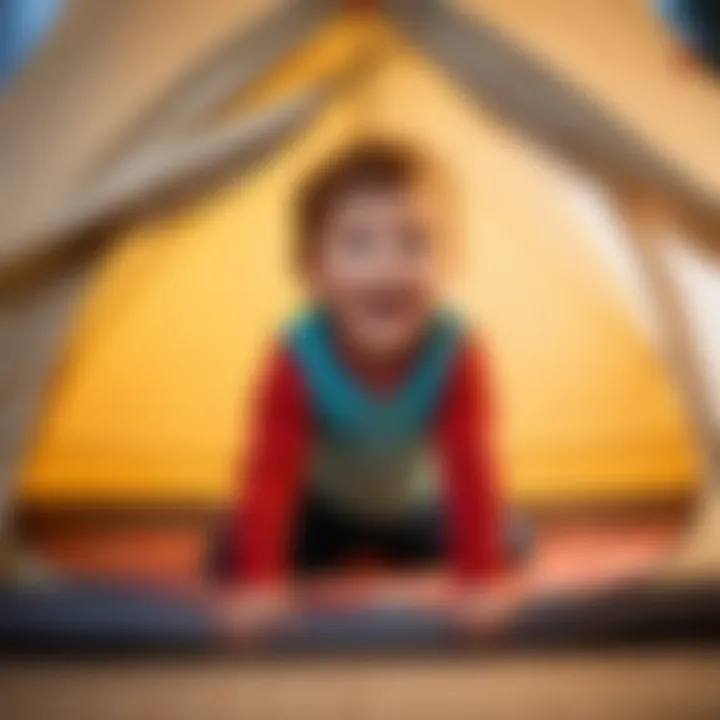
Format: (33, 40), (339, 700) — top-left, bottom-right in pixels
(234, 348), (311, 584)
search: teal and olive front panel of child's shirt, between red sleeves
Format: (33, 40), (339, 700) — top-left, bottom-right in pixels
(288, 310), (463, 517)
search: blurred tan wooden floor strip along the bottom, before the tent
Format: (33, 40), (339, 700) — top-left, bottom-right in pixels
(0, 651), (720, 720)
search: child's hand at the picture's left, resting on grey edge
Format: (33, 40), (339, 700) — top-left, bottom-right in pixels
(219, 588), (291, 638)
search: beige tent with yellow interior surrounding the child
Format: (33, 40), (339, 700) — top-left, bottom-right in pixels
(0, 0), (720, 572)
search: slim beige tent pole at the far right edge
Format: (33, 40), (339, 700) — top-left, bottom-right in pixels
(616, 193), (720, 580)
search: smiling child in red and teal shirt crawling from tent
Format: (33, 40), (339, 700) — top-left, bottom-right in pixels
(233, 143), (502, 600)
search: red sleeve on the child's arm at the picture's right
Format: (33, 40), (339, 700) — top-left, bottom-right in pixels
(438, 344), (503, 582)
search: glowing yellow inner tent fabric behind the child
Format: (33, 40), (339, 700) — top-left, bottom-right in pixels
(23, 17), (697, 504)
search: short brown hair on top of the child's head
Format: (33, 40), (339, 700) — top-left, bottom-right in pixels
(295, 140), (436, 264)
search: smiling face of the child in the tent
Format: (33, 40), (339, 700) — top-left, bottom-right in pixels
(308, 183), (442, 358)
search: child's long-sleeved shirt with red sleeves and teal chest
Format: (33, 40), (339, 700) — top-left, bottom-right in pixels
(236, 313), (501, 582)
